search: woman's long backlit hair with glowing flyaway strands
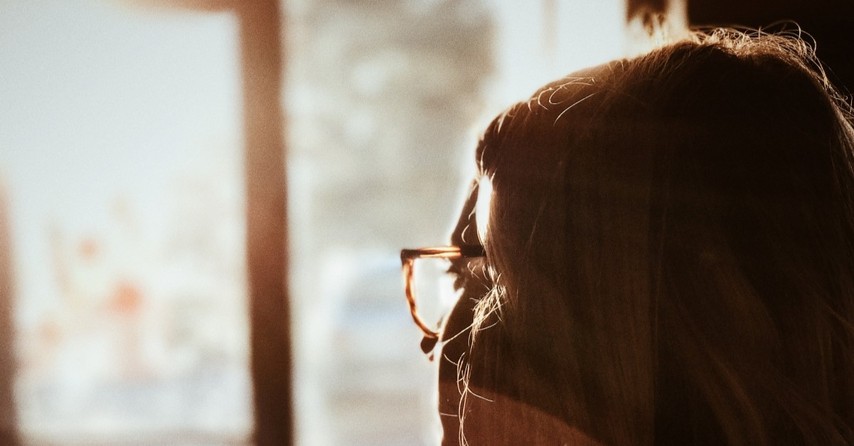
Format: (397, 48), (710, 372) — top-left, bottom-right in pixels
(458, 29), (854, 445)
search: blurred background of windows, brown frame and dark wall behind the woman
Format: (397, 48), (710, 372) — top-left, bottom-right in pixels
(0, 0), (854, 445)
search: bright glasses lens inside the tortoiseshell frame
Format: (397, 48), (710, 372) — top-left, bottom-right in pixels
(413, 258), (458, 331)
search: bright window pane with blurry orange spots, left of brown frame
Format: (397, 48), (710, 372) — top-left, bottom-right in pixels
(0, 0), (253, 445)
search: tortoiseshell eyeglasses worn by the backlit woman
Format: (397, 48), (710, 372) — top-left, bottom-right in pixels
(400, 245), (486, 338)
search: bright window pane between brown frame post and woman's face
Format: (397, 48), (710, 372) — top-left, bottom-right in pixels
(286, 0), (625, 446)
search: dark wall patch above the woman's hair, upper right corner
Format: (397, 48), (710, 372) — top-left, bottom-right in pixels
(687, 0), (854, 92)
